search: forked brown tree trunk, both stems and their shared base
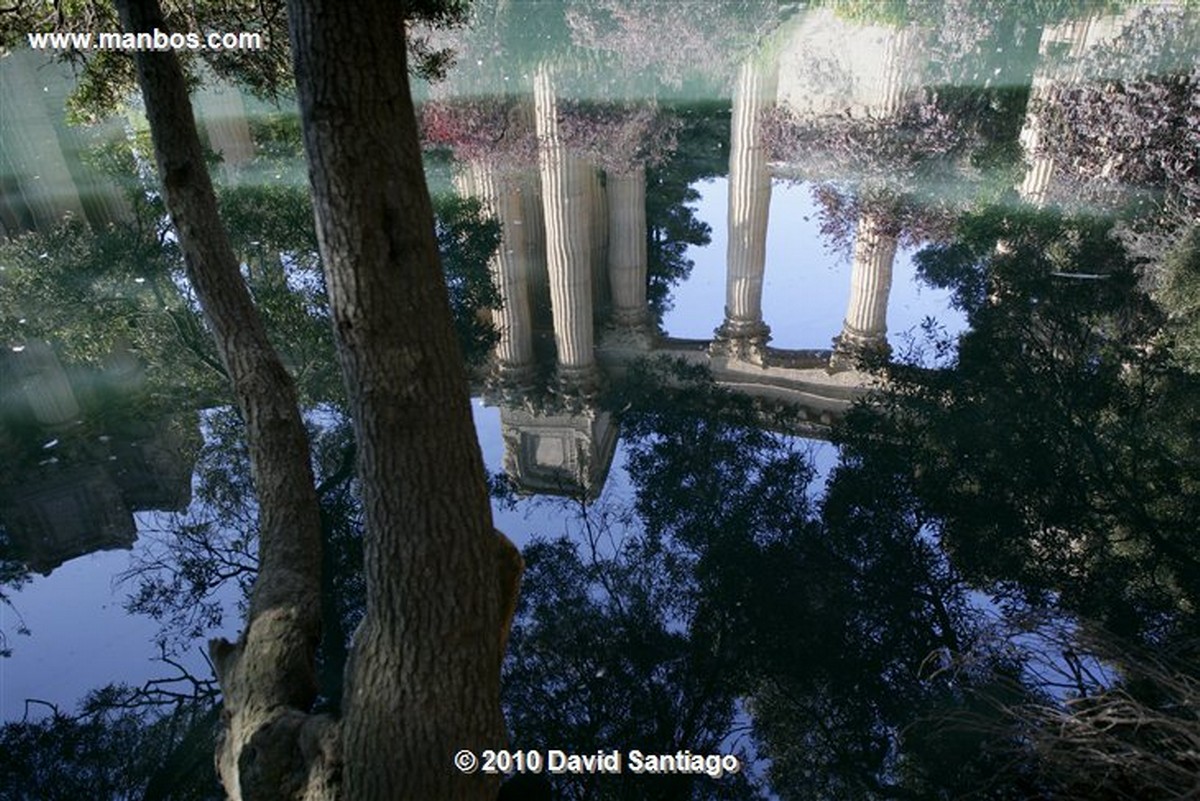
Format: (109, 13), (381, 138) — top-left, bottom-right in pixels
(119, 0), (521, 801)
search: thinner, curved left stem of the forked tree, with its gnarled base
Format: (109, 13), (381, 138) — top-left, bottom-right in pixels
(118, 0), (336, 801)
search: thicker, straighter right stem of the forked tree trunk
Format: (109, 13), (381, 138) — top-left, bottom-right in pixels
(289, 0), (520, 801)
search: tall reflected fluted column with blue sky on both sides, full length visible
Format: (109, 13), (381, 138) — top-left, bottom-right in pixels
(714, 61), (775, 363)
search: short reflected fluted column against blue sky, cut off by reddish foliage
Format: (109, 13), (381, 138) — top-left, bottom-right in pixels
(829, 208), (896, 369)
